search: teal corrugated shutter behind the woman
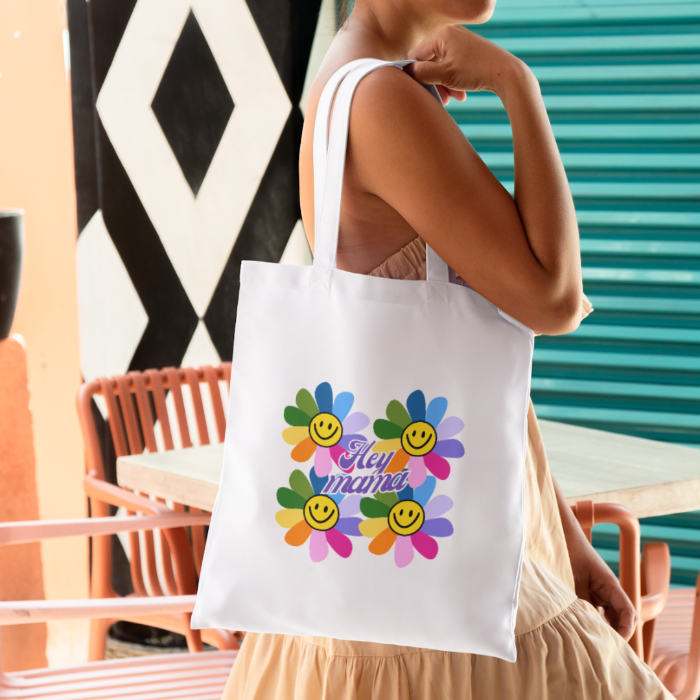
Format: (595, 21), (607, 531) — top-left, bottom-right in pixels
(449, 0), (700, 583)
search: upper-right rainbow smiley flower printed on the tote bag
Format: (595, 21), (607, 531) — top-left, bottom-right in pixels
(372, 391), (464, 488)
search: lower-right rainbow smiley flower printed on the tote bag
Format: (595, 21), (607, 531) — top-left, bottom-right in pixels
(359, 476), (454, 569)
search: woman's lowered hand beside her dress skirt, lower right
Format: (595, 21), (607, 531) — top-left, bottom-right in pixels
(567, 537), (637, 641)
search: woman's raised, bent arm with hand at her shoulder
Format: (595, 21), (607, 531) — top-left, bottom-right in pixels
(348, 27), (582, 334)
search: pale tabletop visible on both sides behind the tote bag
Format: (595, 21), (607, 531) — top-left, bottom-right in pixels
(117, 420), (700, 518)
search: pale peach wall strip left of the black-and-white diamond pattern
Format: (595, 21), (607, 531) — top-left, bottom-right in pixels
(0, 0), (88, 664)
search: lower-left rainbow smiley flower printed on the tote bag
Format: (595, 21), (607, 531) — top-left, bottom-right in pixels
(275, 467), (362, 562)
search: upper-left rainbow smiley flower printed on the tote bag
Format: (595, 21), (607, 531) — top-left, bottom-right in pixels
(282, 382), (369, 477)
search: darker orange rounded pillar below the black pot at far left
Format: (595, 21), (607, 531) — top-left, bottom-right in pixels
(0, 335), (46, 672)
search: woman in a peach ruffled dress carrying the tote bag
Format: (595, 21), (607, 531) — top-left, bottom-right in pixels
(224, 0), (671, 700)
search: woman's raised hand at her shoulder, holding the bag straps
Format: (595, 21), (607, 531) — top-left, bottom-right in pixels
(405, 25), (529, 104)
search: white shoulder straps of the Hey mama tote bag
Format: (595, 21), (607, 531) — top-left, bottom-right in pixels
(313, 59), (449, 282)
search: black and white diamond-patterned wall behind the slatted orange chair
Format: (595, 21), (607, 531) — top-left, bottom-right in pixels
(68, 0), (321, 379)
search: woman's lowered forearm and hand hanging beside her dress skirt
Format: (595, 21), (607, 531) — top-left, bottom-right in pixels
(552, 477), (637, 641)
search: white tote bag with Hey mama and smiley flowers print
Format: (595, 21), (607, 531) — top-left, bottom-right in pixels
(192, 59), (533, 661)
